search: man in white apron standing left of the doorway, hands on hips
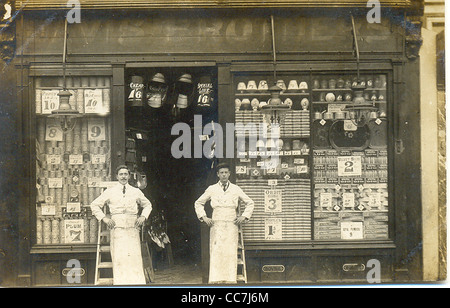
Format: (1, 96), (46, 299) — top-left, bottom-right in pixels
(91, 165), (152, 285)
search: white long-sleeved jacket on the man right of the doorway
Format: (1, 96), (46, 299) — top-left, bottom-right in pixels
(194, 182), (255, 219)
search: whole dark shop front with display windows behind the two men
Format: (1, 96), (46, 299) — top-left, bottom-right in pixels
(10, 1), (422, 285)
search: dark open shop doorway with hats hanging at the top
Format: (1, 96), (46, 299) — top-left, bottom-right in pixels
(125, 67), (218, 275)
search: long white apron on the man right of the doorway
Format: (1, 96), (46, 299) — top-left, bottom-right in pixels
(209, 206), (238, 283)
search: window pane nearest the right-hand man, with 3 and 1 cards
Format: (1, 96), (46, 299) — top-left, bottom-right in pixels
(234, 74), (312, 242)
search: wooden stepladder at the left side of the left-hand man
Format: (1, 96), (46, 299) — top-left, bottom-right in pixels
(94, 217), (114, 286)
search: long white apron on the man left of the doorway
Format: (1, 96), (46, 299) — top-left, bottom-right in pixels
(111, 214), (146, 285)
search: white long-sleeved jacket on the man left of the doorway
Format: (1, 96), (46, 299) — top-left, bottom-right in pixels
(91, 183), (152, 220)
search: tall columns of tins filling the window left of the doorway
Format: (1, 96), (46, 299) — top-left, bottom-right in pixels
(35, 77), (111, 244)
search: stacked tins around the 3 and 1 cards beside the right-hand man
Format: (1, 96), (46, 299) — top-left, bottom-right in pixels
(237, 179), (311, 241)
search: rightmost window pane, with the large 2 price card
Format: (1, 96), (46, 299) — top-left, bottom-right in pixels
(311, 74), (388, 240)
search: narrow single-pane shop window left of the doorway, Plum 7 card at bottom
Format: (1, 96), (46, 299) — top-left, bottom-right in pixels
(35, 76), (111, 245)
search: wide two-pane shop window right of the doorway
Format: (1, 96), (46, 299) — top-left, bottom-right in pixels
(233, 73), (389, 242)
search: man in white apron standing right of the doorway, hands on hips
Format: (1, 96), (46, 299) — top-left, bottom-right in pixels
(194, 164), (254, 283)
